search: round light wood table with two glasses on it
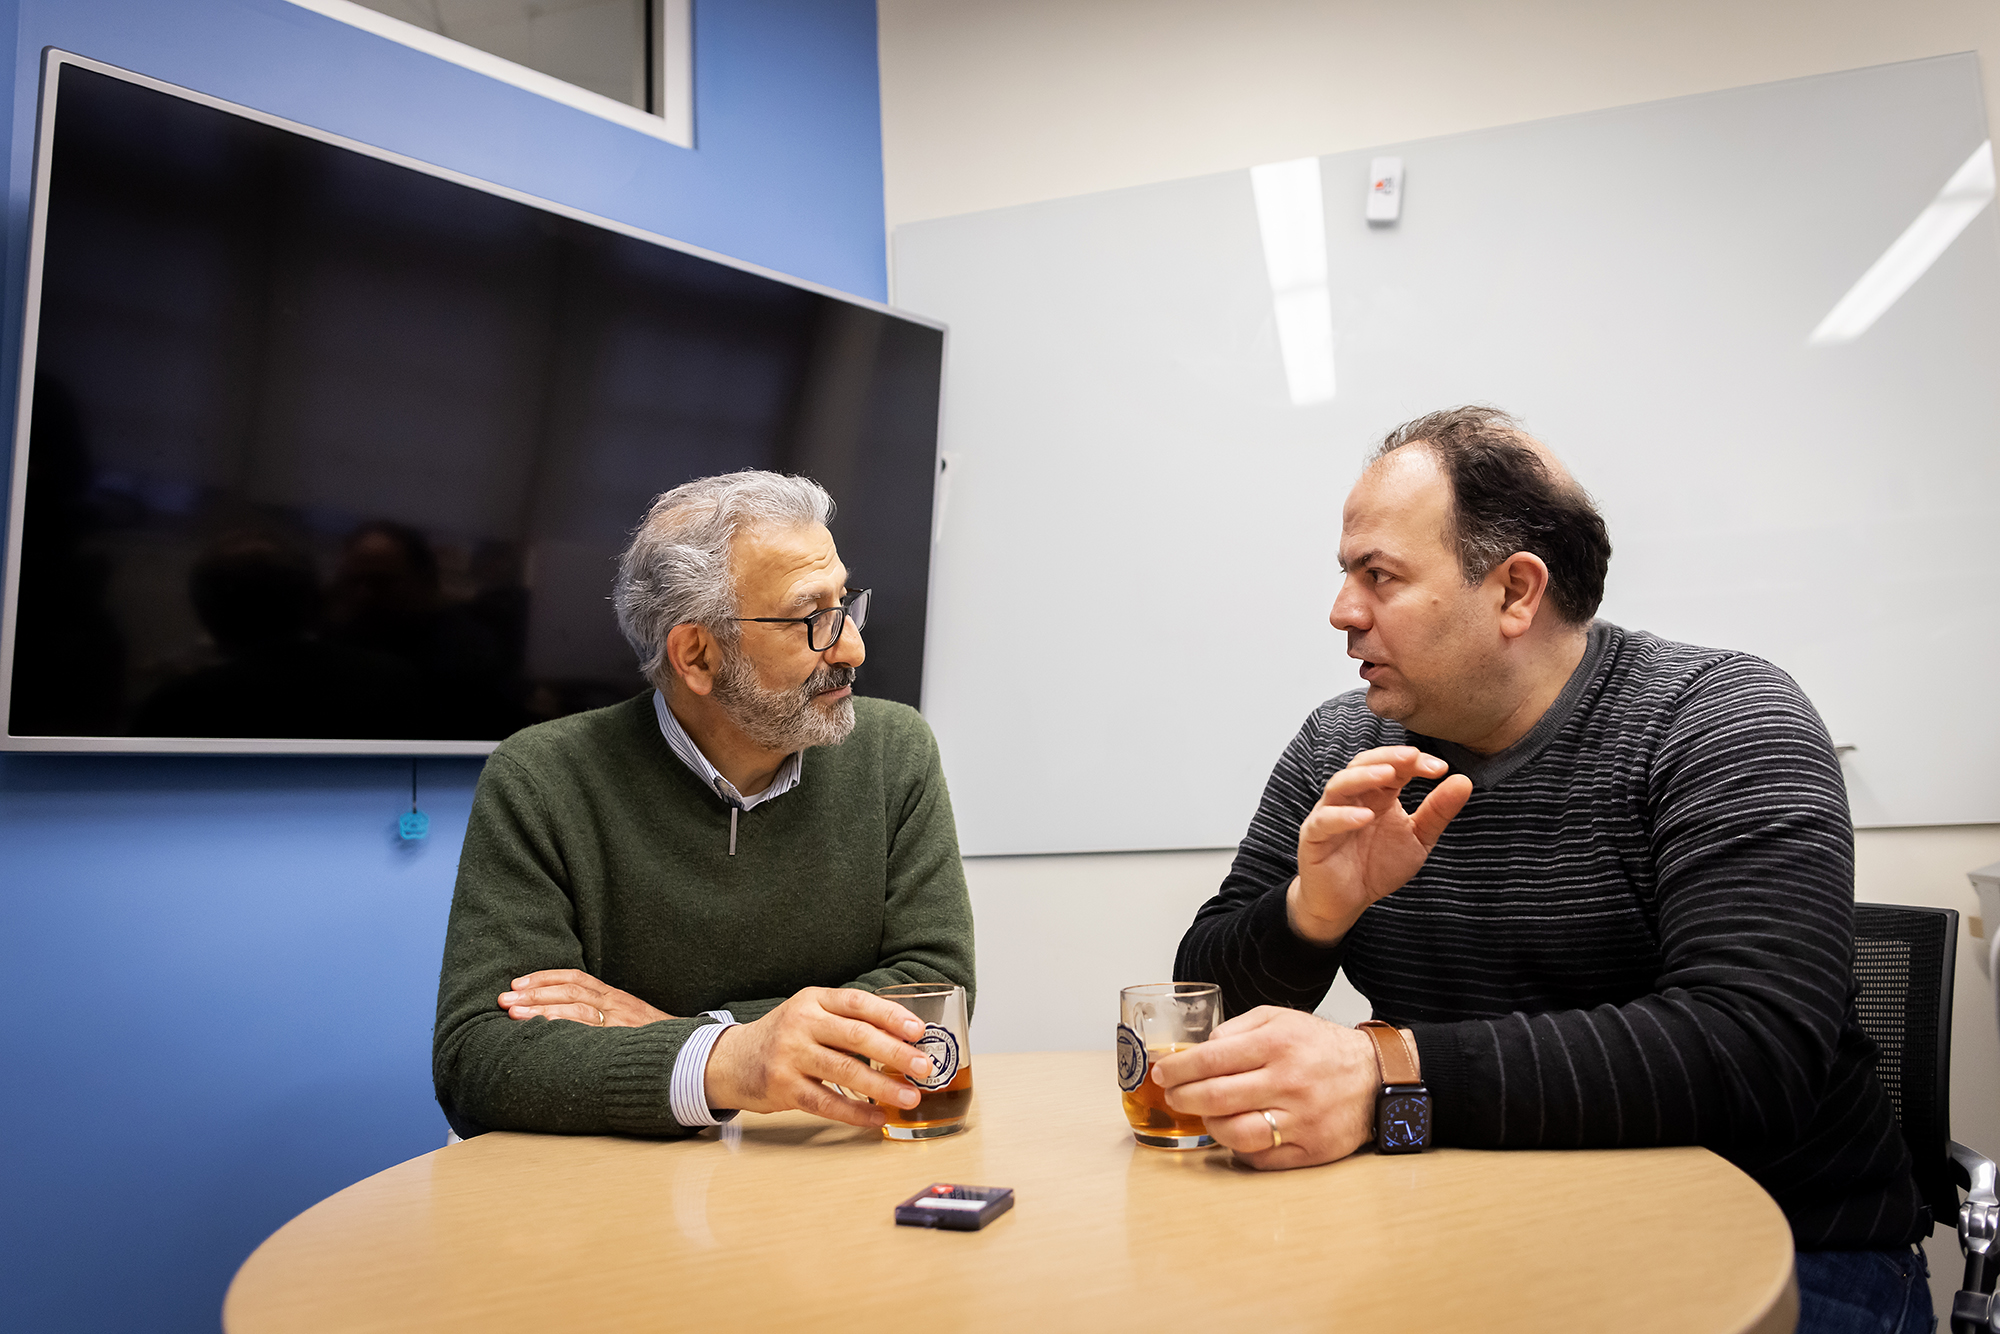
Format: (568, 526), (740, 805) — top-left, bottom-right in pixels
(222, 1052), (1798, 1334)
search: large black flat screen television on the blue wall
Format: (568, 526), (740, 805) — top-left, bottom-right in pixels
(0, 52), (944, 754)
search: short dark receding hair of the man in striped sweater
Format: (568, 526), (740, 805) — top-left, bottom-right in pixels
(1368, 404), (1612, 626)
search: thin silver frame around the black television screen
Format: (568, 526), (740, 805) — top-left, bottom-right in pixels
(0, 46), (952, 756)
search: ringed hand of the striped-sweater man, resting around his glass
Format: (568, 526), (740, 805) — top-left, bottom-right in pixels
(1146, 1006), (1382, 1170)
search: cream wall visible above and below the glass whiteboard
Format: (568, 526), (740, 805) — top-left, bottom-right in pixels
(878, 0), (2000, 1290)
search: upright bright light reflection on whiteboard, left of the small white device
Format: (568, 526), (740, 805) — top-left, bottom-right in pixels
(1250, 158), (1334, 406)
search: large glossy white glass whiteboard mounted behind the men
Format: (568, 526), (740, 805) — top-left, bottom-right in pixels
(894, 56), (2000, 854)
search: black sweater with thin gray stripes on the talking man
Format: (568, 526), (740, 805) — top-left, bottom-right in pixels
(1174, 622), (1930, 1250)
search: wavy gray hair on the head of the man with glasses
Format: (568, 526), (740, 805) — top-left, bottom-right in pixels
(612, 470), (834, 684)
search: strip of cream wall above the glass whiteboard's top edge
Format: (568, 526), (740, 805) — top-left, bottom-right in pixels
(876, 0), (2000, 230)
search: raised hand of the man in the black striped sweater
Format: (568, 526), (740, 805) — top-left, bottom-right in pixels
(1284, 746), (1472, 944)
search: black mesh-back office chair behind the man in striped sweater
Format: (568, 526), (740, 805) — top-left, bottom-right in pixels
(1854, 904), (2000, 1334)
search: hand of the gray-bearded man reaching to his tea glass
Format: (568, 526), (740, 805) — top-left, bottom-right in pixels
(706, 986), (932, 1128)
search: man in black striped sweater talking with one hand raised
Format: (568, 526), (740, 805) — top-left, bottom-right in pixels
(1152, 408), (1930, 1330)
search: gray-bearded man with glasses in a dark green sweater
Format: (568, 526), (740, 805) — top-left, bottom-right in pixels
(432, 472), (972, 1136)
